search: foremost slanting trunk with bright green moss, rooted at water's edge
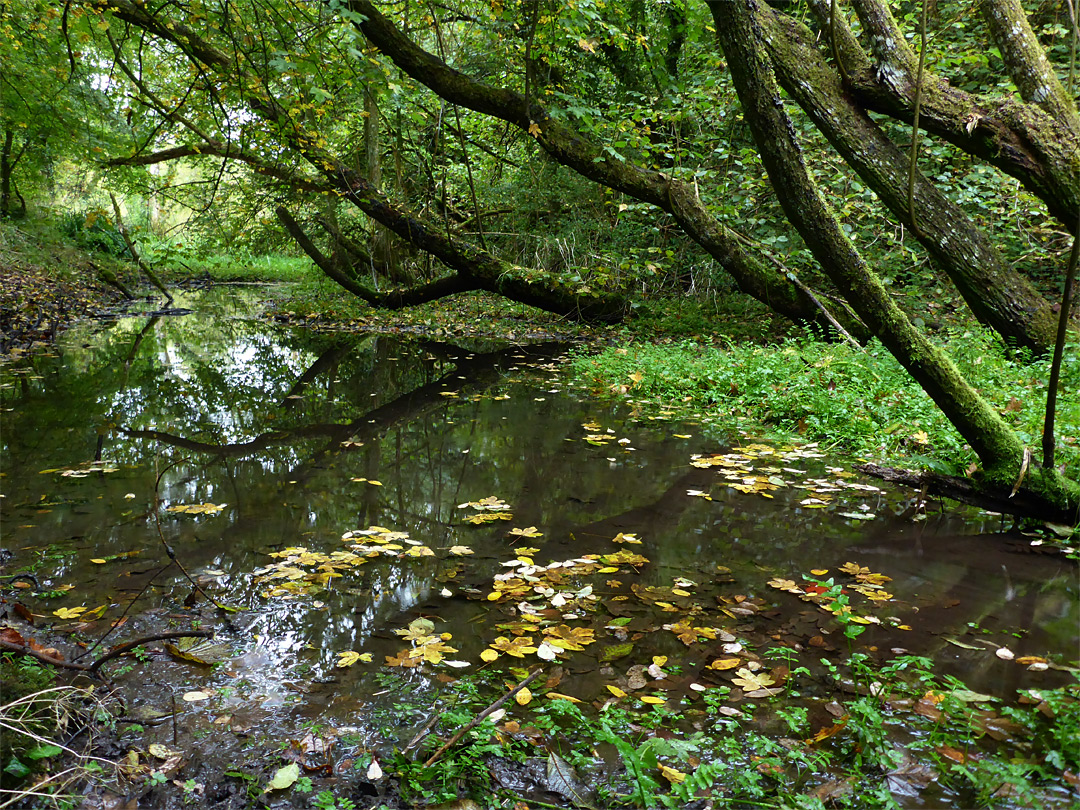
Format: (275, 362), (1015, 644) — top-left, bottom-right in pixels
(708, 0), (1080, 519)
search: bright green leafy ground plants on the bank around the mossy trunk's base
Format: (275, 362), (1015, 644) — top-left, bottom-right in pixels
(572, 330), (1080, 474)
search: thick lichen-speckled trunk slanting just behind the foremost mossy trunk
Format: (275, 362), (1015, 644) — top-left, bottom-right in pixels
(758, 4), (1057, 353)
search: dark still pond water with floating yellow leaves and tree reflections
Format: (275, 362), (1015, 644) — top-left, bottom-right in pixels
(0, 287), (1080, 799)
